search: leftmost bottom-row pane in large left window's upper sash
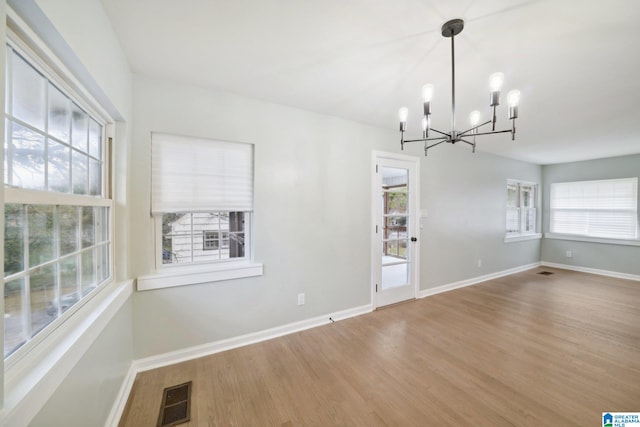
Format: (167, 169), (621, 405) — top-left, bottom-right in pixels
(11, 123), (45, 190)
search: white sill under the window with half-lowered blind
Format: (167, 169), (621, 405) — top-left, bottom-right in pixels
(137, 261), (263, 291)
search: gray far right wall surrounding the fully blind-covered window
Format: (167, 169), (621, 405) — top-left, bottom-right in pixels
(542, 154), (640, 275)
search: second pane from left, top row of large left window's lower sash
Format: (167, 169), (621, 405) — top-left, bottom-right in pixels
(27, 205), (54, 267)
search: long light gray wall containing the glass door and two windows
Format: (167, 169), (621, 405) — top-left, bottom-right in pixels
(130, 76), (540, 358)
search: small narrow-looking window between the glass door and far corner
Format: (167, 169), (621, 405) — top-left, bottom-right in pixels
(506, 179), (538, 238)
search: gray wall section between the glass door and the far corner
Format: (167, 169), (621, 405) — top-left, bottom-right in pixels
(420, 145), (541, 289)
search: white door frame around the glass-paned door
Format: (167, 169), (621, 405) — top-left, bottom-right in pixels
(370, 150), (421, 310)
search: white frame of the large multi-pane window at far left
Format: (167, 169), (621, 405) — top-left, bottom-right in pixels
(3, 21), (115, 366)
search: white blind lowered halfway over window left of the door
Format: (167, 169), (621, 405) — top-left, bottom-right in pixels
(151, 132), (253, 215)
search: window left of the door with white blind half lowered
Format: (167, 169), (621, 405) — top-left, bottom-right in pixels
(152, 133), (253, 267)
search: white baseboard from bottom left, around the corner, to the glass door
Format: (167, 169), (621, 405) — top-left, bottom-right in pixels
(105, 304), (373, 427)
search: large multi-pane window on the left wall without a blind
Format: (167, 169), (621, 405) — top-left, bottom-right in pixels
(3, 43), (111, 357)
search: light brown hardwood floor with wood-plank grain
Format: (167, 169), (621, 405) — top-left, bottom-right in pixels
(120, 267), (640, 427)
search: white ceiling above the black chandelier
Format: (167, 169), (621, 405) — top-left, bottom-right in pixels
(102, 0), (640, 167)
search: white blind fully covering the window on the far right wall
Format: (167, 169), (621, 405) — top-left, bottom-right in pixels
(551, 178), (638, 239)
